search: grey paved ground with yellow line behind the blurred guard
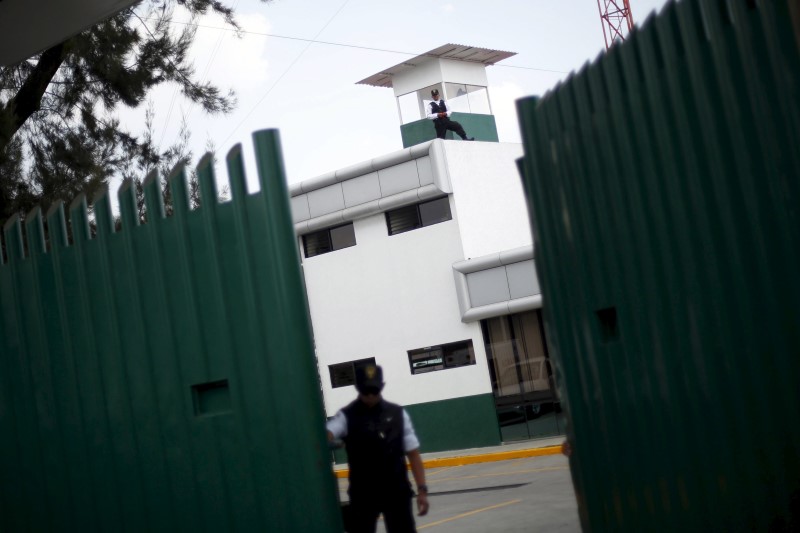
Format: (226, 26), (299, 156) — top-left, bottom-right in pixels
(339, 443), (580, 533)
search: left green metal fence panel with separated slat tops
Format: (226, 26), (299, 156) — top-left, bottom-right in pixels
(0, 131), (342, 532)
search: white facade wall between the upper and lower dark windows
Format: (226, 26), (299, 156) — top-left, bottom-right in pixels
(303, 197), (492, 415)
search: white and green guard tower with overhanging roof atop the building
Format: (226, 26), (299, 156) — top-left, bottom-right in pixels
(358, 44), (516, 148)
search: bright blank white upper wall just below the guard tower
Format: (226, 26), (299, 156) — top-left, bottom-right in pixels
(443, 140), (533, 259)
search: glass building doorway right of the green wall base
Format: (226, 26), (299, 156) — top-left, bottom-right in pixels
(481, 309), (565, 442)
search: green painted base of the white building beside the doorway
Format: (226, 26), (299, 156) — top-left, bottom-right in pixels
(334, 393), (500, 464)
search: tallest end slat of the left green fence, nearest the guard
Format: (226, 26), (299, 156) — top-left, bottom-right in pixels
(253, 130), (342, 531)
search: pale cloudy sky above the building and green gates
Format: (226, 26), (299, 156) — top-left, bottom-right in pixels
(120, 0), (665, 194)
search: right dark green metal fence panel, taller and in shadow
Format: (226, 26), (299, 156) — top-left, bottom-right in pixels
(518, 0), (800, 532)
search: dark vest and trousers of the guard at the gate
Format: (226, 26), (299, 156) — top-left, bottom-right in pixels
(342, 399), (416, 533)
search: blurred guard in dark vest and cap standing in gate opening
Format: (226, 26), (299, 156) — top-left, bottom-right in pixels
(327, 364), (428, 533)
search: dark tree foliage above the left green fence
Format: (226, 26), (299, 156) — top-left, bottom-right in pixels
(0, 0), (260, 221)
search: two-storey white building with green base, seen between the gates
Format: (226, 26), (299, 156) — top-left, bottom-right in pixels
(290, 45), (563, 451)
